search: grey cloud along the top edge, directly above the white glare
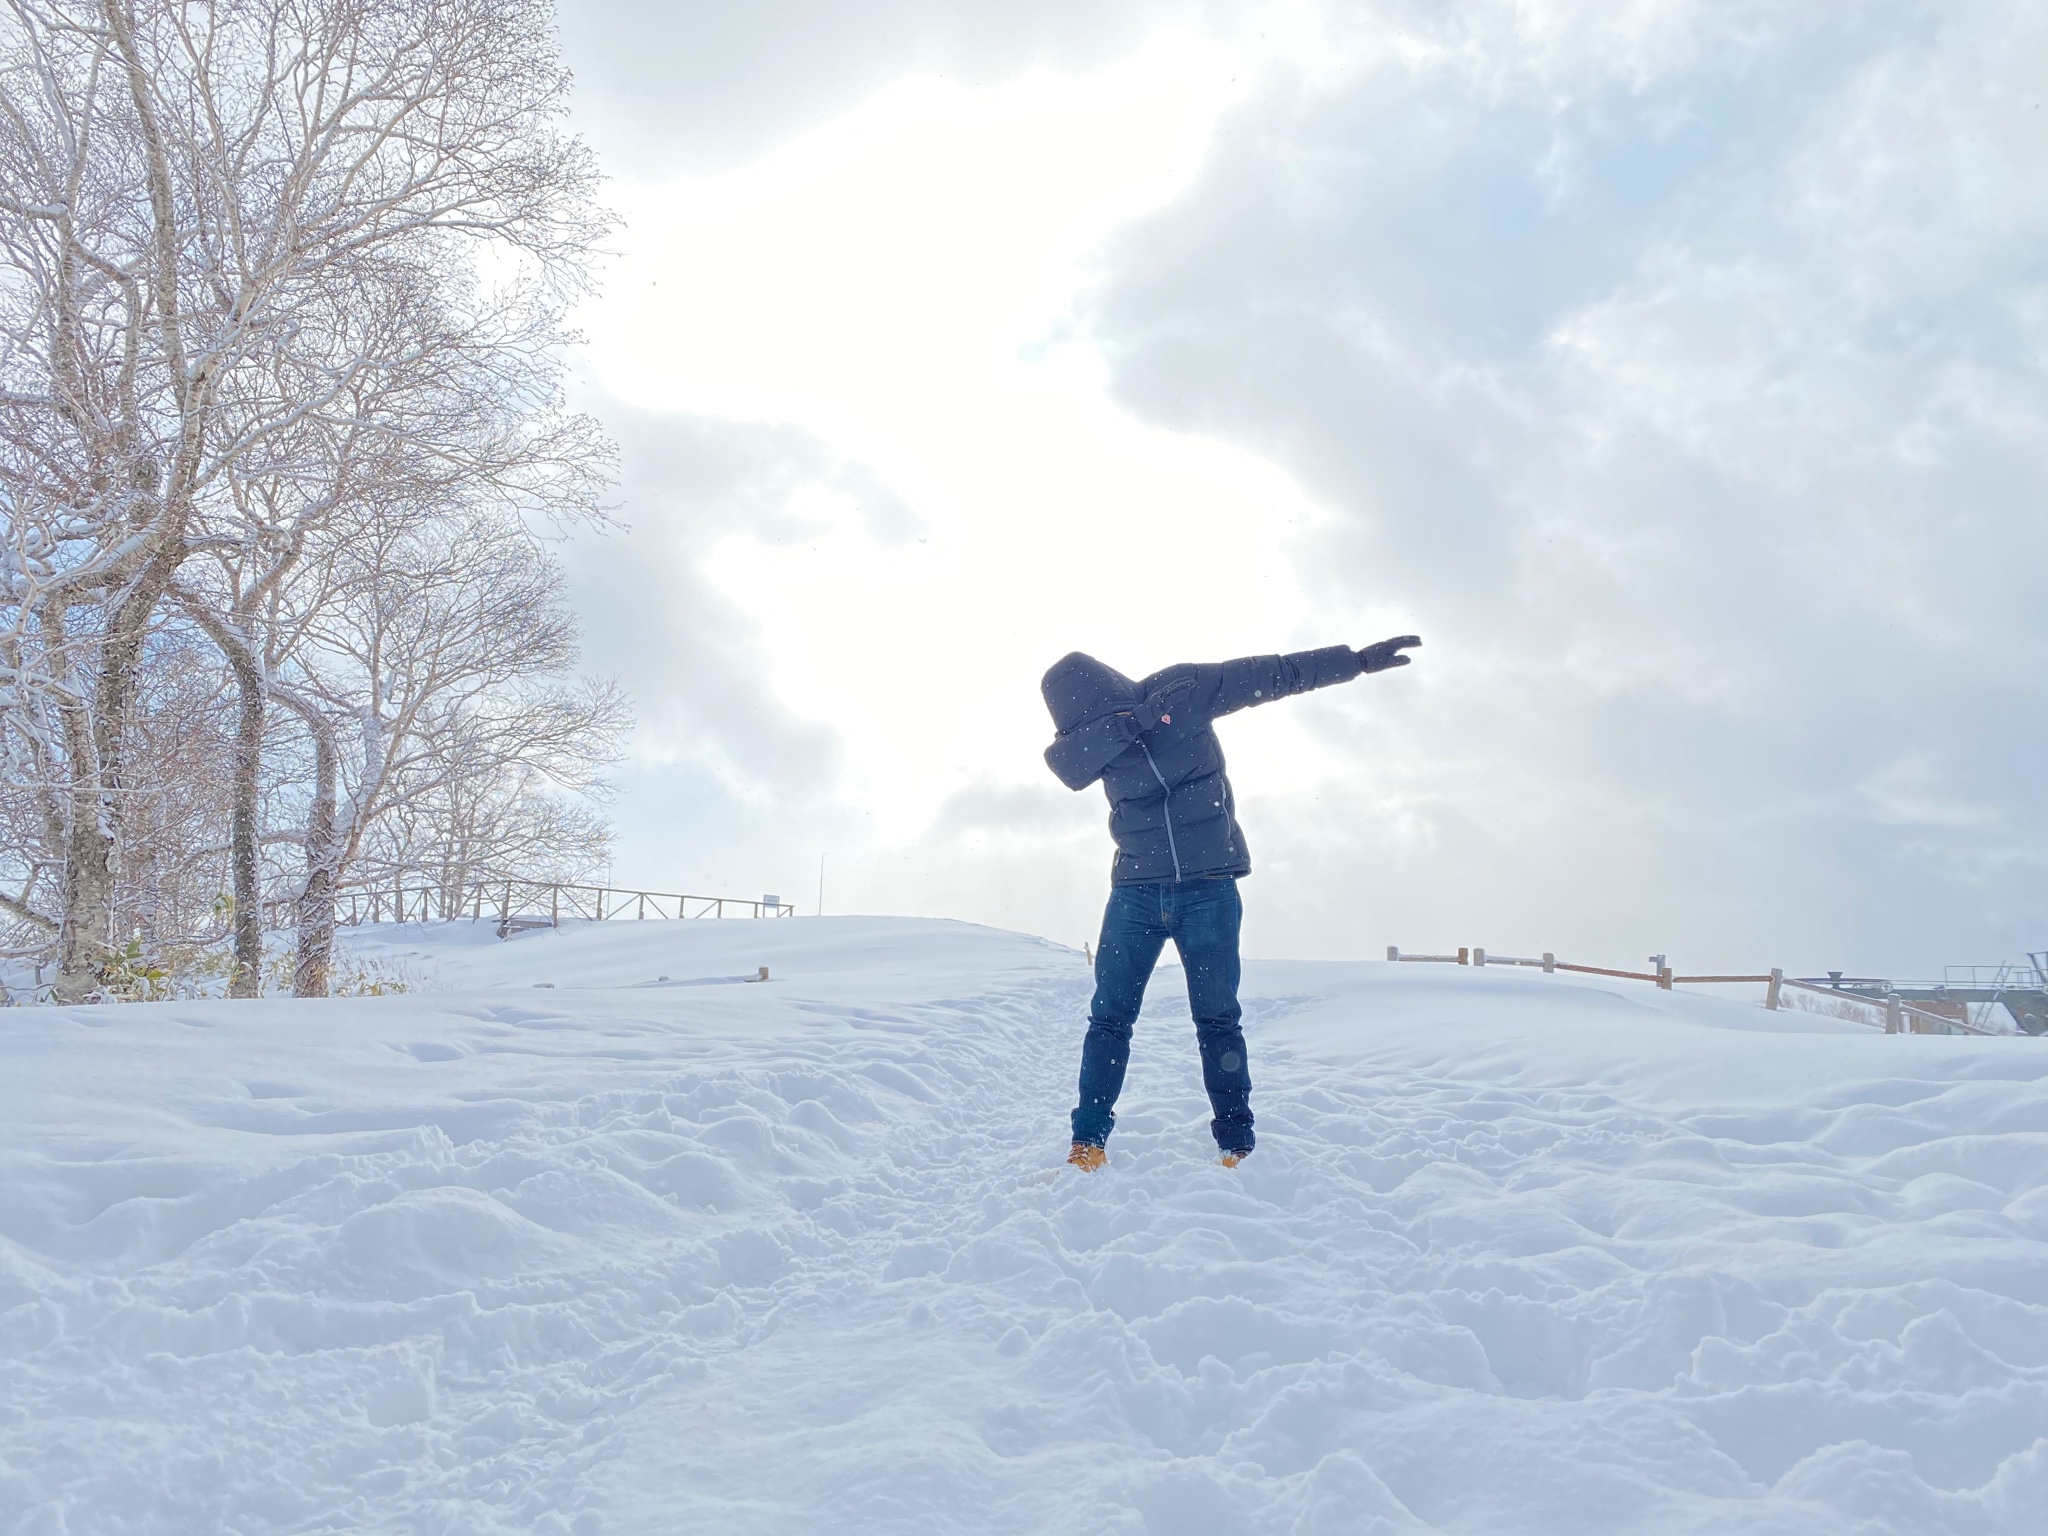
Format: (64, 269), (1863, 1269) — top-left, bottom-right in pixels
(561, 0), (1239, 176)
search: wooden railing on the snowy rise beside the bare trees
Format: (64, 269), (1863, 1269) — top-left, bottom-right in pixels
(264, 881), (797, 936)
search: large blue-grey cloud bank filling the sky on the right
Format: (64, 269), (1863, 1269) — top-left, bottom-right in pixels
(1094, 6), (2048, 967)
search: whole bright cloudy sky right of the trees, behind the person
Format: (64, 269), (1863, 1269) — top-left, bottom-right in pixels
(544, 0), (2048, 975)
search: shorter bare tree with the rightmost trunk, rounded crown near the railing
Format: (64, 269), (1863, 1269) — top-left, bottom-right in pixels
(272, 510), (629, 995)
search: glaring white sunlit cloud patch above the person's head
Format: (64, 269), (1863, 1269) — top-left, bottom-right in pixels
(588, 35), (1351, 860)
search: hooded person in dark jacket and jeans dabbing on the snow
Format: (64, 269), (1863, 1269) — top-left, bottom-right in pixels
(1040, 635), (1421, 1169)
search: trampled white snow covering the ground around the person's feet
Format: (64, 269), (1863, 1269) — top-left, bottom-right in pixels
(0, 920), (2048, 1536)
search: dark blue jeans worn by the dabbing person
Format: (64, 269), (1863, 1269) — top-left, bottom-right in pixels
(1073, 879), (1253, 1153)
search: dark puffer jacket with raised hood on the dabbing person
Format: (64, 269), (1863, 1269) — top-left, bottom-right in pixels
(1038, 645), (1358, 885)
